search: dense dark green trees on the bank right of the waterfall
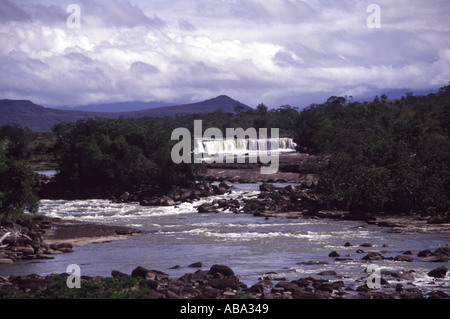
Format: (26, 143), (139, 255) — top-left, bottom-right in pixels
(297, 86), (450, 213)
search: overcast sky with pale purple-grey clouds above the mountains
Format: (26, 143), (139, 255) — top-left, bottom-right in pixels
(0, 0), (450, 108)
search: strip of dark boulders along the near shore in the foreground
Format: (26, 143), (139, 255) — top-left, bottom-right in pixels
(0, 256), (450, 299)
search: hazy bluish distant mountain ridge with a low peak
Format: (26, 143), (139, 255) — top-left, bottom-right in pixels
(0, 95), (252, 132)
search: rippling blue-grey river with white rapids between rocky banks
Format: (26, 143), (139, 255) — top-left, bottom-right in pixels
(0, 184), (450, 293)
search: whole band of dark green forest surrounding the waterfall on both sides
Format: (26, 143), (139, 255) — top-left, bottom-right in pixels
(0, 85), (450, 220)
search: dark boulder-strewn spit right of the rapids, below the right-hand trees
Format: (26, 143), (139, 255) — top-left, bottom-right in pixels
(197, 181), (450, 233)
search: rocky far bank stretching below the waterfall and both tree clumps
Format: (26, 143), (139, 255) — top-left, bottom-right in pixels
(37, 153), (450, 232)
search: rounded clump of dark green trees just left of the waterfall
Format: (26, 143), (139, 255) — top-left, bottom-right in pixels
(53, 118), (202, 195)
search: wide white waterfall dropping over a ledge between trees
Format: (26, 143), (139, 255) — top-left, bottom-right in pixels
(195, 137), (297, 156)
